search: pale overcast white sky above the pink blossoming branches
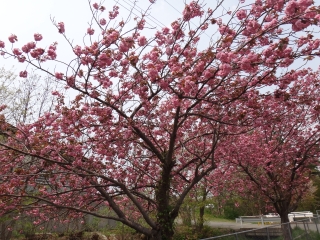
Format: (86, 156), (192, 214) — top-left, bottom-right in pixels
(0, 0), (239, 73)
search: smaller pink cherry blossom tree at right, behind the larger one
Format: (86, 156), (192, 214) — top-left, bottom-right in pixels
(221, 70), (320, 239)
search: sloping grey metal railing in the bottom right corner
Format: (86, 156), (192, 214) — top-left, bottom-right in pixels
(202, 217), (320, 240)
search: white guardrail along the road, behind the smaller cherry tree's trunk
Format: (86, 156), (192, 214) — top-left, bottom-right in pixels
(236, 211), (313, 226)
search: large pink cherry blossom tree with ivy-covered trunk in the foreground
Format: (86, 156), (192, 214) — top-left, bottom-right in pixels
(0, 0), (320, 239)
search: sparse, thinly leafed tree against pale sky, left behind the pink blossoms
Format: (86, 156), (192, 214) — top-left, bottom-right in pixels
(0, 68), (64, 126)
